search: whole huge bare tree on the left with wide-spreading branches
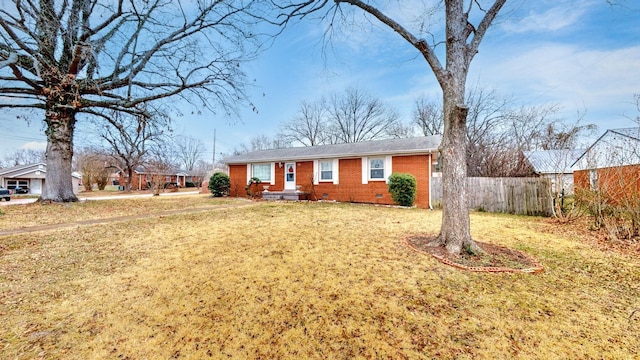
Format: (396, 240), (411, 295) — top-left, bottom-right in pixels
(0, 0), (268, 202)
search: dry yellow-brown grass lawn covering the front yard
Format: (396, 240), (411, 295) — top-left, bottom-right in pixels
(0, 196), (640, 359)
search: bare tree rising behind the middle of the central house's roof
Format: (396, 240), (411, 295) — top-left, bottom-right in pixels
(328, 88), (400, 143)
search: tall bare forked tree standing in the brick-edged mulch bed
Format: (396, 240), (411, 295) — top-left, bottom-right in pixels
(283, 0), (506, 254)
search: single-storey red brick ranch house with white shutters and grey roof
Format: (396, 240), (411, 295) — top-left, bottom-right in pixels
(225, 136), (440, 208)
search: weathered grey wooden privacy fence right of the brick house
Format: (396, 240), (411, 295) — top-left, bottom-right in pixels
(431, 177), (553, 216)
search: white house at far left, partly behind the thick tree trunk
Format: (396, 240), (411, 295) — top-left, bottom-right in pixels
(0, 163), (82, 195)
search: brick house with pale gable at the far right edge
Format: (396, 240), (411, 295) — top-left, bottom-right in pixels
(574, 127), (640, 200)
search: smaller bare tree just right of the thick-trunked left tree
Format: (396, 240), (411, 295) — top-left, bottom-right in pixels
(98, 111), (169, 191)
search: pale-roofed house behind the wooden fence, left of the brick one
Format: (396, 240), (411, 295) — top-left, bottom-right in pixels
(523, 149), (585, 195)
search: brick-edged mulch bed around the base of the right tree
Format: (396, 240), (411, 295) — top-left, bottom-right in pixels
(403, 235), (544, 273)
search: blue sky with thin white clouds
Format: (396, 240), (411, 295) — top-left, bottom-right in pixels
(0, 0), (640, 156)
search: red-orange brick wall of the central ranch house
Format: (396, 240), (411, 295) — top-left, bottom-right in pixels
(229, 155), (430, 208)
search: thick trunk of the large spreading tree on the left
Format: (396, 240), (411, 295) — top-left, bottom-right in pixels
(39, 111), (78, 202)
